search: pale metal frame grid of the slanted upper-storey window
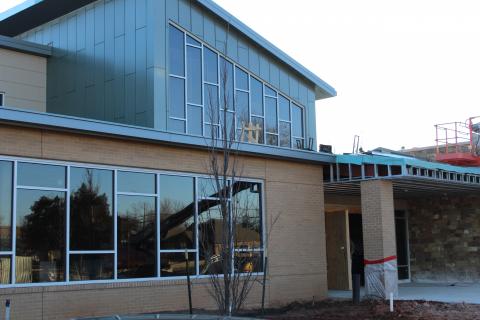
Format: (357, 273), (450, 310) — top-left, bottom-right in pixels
(166, 20), (307, 149)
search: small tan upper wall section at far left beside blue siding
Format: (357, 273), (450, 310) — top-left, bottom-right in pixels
(0, 48), (47, 112)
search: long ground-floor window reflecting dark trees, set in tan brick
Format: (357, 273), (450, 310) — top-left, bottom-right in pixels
(0, 159), (263, 287)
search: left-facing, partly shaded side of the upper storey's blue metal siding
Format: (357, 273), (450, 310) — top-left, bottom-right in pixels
(19, 0), (154, 127)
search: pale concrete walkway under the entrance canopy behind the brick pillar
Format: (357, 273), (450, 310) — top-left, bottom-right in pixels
(328, 283), (480, 304)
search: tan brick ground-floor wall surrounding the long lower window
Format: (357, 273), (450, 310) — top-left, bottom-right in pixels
(0, 125), (327, 319)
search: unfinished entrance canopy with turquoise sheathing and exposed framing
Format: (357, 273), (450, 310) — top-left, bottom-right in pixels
(323, 152), (480, 198)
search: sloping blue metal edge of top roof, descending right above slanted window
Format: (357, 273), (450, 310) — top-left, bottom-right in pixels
(197, 0), (337, 100)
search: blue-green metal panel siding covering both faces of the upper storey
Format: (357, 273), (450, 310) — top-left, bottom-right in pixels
(16, 0), (322, 149)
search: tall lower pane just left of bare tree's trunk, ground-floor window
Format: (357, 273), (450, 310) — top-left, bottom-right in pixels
(198, 199), (224, 274)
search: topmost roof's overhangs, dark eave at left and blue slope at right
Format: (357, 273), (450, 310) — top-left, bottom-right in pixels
(0, 0), (337, 100)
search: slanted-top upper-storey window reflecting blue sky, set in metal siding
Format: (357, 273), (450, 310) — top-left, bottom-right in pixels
(168, 25), (305, 148)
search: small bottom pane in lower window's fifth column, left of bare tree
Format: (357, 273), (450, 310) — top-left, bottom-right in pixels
(160, 252), (197, 277)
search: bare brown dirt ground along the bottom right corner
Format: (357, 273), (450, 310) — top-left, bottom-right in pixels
(256, 300), (480, 320)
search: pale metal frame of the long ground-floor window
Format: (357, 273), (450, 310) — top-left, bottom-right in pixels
(0, 156), (267, 289)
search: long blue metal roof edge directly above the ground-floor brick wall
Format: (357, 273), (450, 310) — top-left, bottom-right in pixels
(0, 107), (335, 164)
